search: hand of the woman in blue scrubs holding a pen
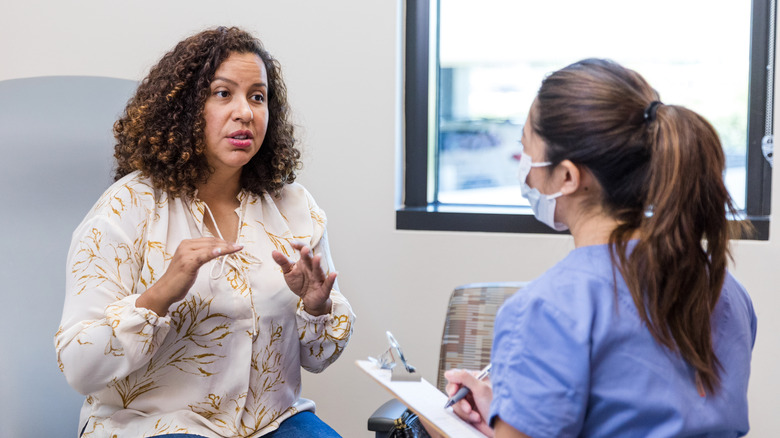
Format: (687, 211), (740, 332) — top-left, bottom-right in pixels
(444, 370), (493, 437)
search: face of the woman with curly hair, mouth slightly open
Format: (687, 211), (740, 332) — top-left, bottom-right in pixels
(203, 53), (268, 172)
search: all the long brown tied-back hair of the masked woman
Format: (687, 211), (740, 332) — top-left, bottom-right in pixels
(532, 59), (748, 393)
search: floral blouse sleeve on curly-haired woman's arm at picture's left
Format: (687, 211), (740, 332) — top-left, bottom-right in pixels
(55, 180), (170, 394)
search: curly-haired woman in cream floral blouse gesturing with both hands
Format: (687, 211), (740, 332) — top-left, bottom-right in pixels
(55, 27), (355, 438)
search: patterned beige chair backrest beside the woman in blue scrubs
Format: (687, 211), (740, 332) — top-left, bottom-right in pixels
(436, 282), (528, 391)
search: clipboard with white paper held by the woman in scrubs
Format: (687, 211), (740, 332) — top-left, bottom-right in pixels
(355, 360), (485, 438)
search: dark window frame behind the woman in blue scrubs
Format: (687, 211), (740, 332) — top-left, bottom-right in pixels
(396, 0), (776, 240)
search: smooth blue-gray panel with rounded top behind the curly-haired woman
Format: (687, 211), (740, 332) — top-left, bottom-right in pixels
(0, 76), (136, 437)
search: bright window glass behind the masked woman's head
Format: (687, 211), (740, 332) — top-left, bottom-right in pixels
(435, 0), (751, 209)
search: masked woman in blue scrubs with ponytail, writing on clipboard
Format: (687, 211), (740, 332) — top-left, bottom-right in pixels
(446, 59), (756, 438)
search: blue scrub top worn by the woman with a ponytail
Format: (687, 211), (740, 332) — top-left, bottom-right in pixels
(490, 245), (756, 438)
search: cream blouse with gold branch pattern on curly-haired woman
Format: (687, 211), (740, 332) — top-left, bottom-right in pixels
(55, 172), (355, 437)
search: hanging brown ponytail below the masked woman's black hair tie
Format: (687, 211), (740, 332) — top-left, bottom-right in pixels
(616, 106), (734, 393)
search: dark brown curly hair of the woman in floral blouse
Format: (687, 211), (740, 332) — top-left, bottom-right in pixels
(114, 27), (301, 197)
